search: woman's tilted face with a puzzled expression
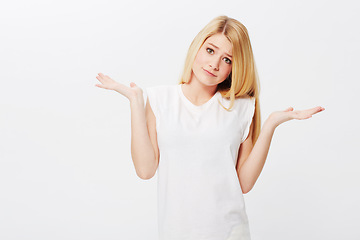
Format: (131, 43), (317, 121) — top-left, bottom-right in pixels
(192, 33), (232, 86)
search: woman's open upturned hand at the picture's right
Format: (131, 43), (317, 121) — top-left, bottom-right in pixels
(268, 106), (325, 127)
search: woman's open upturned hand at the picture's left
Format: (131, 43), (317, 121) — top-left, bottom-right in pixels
(95, 73), (143, 101)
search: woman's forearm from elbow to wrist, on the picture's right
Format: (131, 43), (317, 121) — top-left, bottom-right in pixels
(239, 118), (276, 193)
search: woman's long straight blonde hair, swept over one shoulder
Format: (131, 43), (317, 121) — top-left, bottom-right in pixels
(179, 15), (261, 144)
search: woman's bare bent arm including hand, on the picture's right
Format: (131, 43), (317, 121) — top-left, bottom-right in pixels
(238, 107), (325, 193)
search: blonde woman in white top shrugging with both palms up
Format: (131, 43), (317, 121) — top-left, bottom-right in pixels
(96, 16), (324, 240)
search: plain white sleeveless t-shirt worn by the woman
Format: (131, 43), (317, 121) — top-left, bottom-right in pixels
(146, 84), (255, 240)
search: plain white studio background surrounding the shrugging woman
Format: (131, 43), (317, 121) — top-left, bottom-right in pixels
(0, 0), (360, 240)
